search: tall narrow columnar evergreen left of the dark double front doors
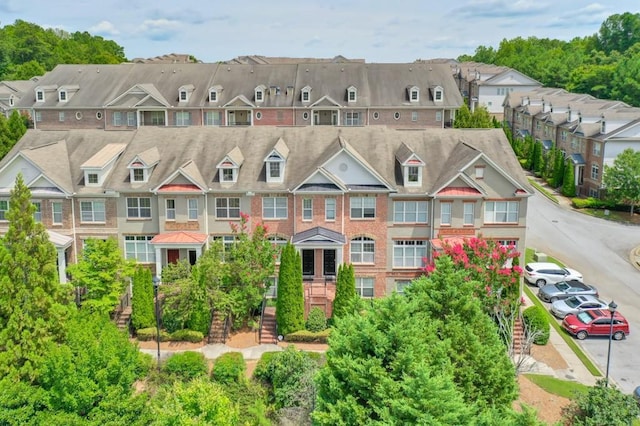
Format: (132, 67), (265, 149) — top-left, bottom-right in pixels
(276, 243), (304, 335)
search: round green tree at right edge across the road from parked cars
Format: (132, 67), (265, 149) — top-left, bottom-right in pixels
(602, 148), (640, 215)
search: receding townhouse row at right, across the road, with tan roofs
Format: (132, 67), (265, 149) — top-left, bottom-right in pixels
(504, 88), (640, 197)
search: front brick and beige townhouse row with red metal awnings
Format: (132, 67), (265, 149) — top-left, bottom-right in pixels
(0, 126), (533, 297)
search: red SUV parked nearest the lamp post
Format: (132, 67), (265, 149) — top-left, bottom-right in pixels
(562, 309), (629, 340)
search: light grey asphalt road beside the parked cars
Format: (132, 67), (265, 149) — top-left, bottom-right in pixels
(526, 194), (640, 393)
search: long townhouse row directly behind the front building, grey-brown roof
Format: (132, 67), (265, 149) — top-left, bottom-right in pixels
(15, 62), (463, 130)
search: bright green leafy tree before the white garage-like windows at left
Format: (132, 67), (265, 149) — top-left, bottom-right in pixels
(67, 238), (135, 314)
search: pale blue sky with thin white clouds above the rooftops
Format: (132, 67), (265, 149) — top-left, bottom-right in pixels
(0, 0), (640, 62)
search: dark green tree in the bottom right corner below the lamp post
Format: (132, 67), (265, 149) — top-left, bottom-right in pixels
(563, 379), (640, 426)
